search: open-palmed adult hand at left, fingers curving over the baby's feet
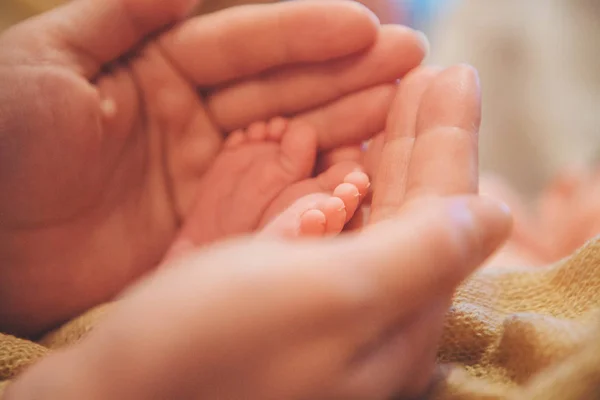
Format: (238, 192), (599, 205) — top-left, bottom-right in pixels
(0, 0), (425, 334)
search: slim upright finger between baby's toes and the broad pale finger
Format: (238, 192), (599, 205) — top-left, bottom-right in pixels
(371, 67), (439, 222)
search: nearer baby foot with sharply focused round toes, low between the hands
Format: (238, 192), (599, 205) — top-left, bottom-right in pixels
(260, 171), (370, 238)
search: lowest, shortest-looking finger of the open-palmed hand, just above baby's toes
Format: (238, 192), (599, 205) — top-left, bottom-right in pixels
(293, 84), (396, 150)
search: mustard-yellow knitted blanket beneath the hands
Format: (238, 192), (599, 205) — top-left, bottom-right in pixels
(0, 238), (600, 400)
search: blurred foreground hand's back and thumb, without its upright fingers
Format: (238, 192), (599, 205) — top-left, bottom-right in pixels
(5, 196), (510, 400)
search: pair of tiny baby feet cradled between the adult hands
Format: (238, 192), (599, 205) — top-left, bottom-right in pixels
(169, 118), (370, 258)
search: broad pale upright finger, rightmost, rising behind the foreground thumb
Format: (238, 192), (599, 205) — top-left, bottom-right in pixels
(406, 66), (481, 203)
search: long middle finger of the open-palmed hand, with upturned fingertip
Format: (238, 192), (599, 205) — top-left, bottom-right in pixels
(207, 25), (427, 130)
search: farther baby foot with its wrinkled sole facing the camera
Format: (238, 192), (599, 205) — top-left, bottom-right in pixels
(177, 118), (317, 244)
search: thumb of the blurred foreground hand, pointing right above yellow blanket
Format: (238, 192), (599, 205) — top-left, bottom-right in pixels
(321, 196), (512, 319)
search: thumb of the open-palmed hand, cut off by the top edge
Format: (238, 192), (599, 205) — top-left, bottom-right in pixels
(38, 0), (199, 78)
